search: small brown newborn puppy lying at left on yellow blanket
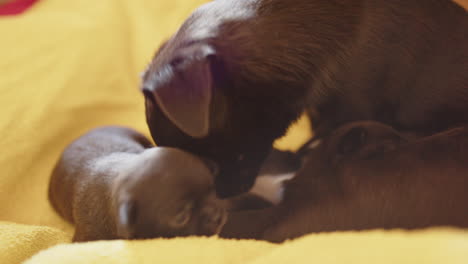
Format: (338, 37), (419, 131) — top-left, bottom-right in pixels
(49, 127), (226, 241)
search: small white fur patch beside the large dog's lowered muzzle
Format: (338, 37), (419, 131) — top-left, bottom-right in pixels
(250, 172), (295, 204)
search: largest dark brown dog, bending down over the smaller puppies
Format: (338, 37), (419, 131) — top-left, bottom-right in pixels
(142, 0), (468, 196)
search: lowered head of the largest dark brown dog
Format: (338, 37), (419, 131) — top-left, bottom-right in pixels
(142, 0), (310, 197)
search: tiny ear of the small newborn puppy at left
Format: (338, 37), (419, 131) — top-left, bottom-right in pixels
(117, 201), (138, 239)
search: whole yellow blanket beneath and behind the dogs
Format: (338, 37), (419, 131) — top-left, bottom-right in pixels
(0, 0), (468, 264)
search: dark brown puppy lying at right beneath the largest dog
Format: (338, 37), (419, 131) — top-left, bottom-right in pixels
(221, 122), (468, 242)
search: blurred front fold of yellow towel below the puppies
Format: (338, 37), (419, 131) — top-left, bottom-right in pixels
(26, 229), (468, 264)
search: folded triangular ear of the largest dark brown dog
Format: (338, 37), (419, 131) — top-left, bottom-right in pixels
(143, 46), (215, 138)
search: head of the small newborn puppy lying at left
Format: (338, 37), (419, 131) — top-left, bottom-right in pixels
(113, 148), (226, 239)
